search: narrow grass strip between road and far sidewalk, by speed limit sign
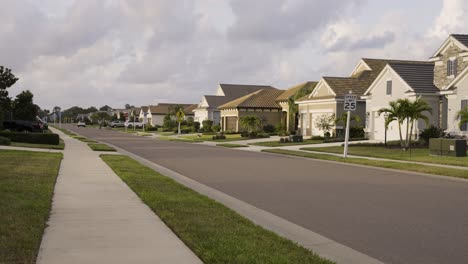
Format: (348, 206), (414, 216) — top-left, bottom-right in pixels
(262, 149), (468, 179)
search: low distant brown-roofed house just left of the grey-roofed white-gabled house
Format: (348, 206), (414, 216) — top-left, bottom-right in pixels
(147, 103), (197, 126)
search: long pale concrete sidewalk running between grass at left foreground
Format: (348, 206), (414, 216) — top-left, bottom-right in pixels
(37, 130), (202, 264)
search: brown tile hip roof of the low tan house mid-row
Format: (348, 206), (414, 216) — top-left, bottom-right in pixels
(219, 89), (284, 109)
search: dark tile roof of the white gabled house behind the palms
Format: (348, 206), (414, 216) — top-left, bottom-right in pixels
(389, 62), (439, 93)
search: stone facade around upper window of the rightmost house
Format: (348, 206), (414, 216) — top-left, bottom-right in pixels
(434, 43), (468, 89)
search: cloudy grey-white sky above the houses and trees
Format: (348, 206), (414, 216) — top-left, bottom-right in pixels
(0, 0), (468, 109)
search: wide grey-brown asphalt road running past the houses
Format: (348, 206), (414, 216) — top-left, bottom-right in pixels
(66, 126), (468, 264)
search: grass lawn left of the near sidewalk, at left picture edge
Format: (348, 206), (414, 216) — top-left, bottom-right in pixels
(0, 150), (62, 263)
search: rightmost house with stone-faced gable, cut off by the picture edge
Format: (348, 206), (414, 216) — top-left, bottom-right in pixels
(429, 34), (468, 135)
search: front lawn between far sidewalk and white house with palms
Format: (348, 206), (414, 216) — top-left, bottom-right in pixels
(301, 145), (468, 167)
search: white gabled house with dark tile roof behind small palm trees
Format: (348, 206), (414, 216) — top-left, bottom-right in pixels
(361, 61), (444, 140)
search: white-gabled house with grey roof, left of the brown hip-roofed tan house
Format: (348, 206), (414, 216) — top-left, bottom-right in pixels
(193, 83), (276, 126)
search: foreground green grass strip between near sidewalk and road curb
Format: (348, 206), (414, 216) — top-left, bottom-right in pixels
(101, 155), (332, 264)
